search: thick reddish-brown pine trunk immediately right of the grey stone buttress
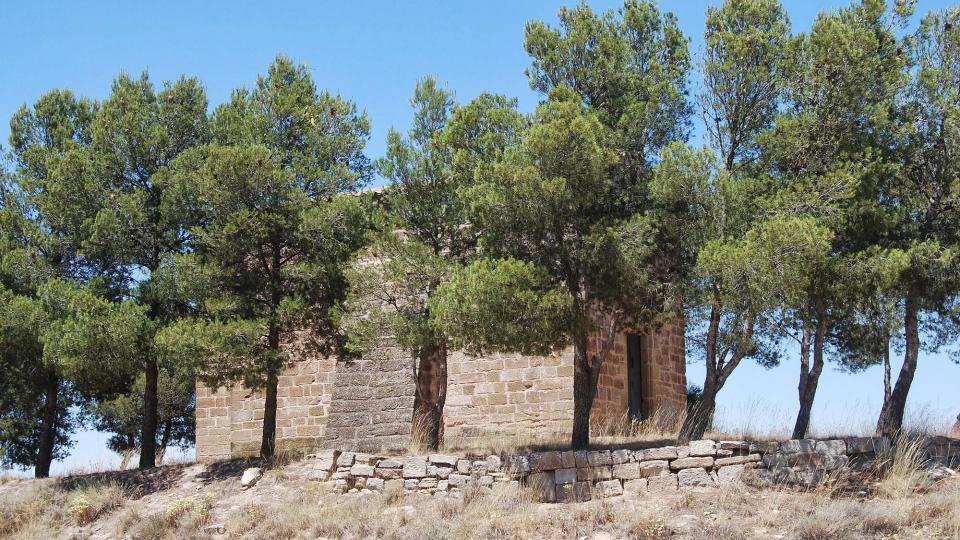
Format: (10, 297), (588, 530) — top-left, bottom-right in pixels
(410, 342), (447, 450)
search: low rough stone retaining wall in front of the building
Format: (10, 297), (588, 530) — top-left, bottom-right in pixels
(307, 437), (960, 502)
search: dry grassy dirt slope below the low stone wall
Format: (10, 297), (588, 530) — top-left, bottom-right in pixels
(0, 460), (960, 540)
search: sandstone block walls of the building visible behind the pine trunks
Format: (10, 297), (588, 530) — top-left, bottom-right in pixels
(196, 320), (686, 461)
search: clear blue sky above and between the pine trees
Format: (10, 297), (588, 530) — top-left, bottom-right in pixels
(0, 0), (960, 472)
